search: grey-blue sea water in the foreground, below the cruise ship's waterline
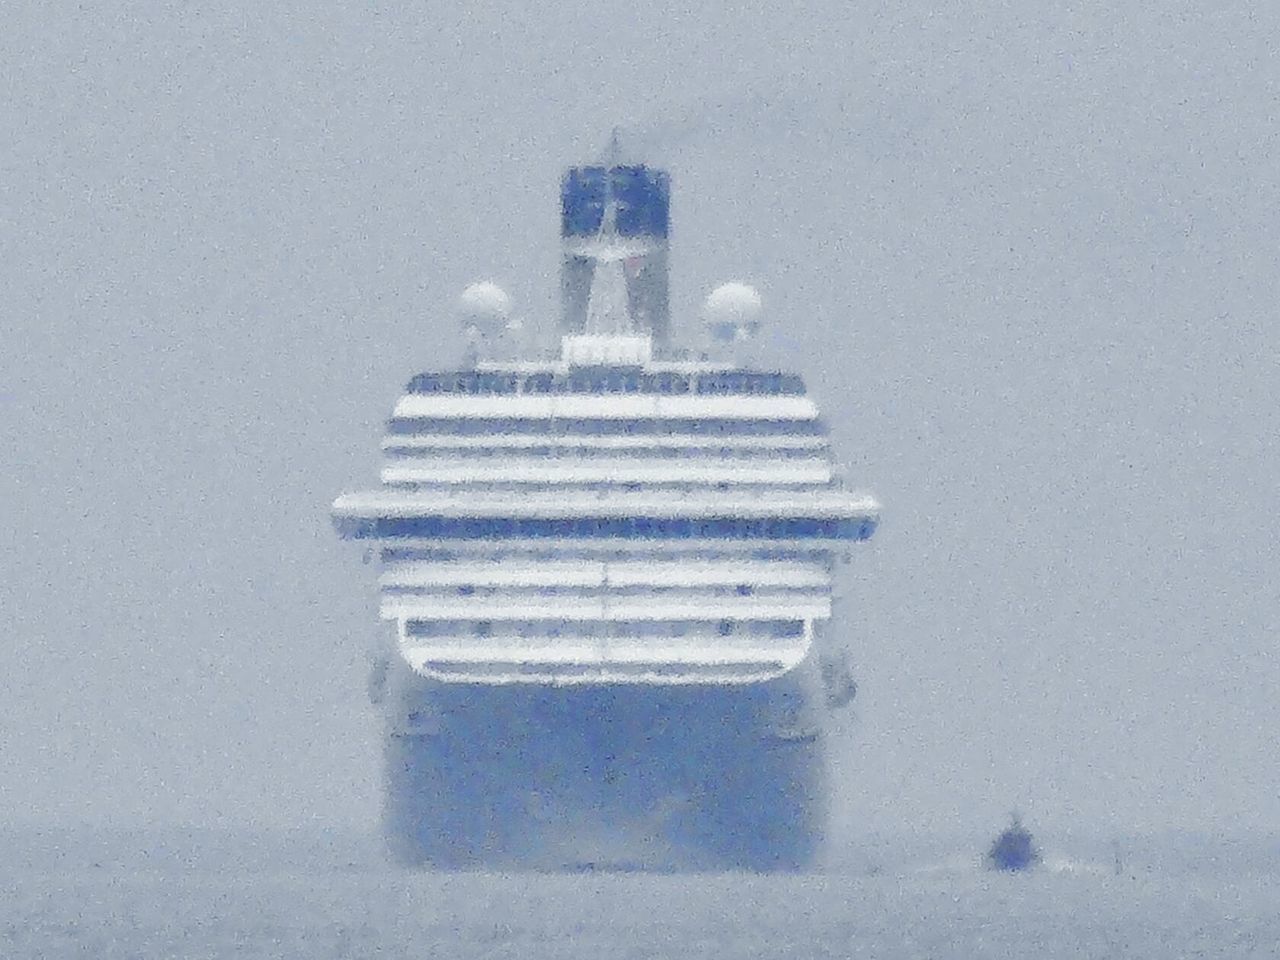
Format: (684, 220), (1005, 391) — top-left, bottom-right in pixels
(0, 856), (1280, 960)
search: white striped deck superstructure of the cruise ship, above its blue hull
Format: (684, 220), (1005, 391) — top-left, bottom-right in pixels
(333, 364), (879, 684)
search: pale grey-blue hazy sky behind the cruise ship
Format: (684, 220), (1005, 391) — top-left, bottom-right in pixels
(0, 0), (1280, 832)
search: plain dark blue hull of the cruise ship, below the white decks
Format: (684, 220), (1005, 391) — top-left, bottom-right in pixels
(384, 668), (828, 870)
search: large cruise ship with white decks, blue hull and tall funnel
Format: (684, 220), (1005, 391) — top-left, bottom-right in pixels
(333, 164), (879, 870)
